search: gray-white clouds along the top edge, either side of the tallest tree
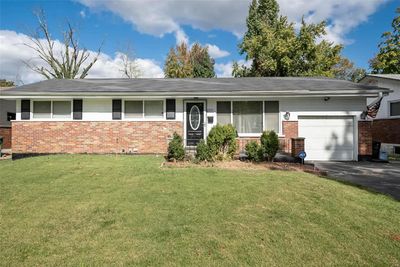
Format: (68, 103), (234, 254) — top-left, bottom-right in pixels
(78, 0), (388, 42)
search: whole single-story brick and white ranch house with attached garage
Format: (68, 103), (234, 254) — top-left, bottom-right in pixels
(2, 78), (389, 161)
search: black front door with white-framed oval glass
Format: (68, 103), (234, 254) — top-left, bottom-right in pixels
(186, 102), (204, 146)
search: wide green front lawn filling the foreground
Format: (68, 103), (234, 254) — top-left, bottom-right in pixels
(0, 155), (400, 266)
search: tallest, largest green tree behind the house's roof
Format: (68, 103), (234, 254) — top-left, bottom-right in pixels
(233, 0), (342, 77)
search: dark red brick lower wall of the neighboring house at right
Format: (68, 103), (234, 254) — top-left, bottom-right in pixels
(372, 118), (400, 144)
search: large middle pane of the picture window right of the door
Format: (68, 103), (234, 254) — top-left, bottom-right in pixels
(232, 101), (263, 133)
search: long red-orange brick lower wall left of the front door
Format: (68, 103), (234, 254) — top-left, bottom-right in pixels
(12, 121), (183, 154)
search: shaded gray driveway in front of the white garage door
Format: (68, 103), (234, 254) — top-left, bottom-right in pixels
(314, 162), (400, 201)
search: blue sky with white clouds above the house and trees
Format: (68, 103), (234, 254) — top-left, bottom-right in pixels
(0, 0), (400, 84)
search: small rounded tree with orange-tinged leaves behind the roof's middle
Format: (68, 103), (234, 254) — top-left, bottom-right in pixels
(164, 43), (215, 78)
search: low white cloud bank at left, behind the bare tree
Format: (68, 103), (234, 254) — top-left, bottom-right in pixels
(0, 30), (164, 84)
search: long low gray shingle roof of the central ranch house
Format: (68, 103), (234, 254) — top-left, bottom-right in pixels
(0, 77), (389, 96)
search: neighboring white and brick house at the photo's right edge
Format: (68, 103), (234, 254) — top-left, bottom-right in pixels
(360, 74), (400, 155)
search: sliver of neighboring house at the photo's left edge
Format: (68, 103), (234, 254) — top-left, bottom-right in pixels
(0, 87), (16, 149)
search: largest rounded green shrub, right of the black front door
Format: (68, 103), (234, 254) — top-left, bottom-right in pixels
(207, 124), (237, 160)
